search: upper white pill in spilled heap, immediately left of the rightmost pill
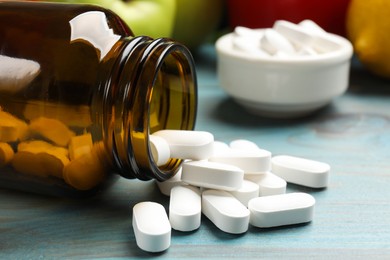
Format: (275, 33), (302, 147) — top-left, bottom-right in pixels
(209, 149), (271, 173)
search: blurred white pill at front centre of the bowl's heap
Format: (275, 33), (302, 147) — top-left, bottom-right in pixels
(260, 29), (295, 55)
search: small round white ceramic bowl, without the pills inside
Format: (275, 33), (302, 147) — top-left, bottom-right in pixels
(216, 29), (353, 117)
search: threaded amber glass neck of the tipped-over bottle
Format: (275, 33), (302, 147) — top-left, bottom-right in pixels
(97, 37), (197, 180)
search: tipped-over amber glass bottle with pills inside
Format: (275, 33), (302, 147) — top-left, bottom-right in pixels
(0, 1), (197, 195)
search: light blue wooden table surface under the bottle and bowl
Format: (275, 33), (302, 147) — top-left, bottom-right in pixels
(0, 45), (390, 259)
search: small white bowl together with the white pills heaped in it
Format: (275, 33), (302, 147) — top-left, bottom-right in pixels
(215, 20), (353, 117)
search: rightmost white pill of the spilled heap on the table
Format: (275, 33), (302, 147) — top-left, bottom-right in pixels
(271, 155), (330, 188)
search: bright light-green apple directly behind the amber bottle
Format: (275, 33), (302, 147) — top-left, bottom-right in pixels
(46, 0), (175, 38)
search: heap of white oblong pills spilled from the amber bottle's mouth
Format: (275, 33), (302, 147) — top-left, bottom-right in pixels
(133, 130), (330, 252)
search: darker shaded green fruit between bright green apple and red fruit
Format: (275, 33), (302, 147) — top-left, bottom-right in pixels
(172, 0), (225, 49)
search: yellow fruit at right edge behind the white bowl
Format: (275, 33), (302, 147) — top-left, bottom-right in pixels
(346, 0), (390, 78)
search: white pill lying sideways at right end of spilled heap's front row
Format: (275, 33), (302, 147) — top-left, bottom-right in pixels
(248, 192), (315, 228)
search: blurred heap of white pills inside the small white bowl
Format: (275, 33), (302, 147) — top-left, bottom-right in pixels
(232, 20), (342, 58)
